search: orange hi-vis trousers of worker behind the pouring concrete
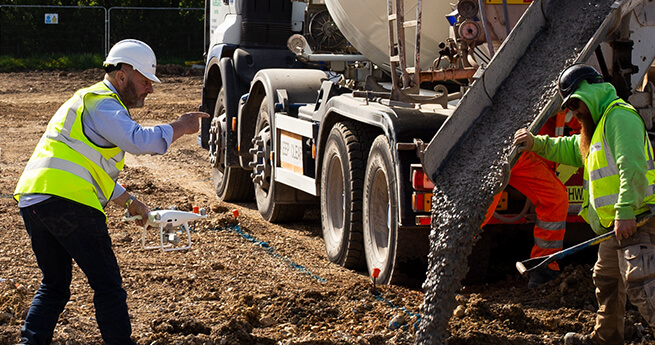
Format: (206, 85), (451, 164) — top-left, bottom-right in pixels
(484, 152), (569, 271)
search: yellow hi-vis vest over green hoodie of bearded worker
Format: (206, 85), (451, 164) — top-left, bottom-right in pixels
(580, 100), (655, 232)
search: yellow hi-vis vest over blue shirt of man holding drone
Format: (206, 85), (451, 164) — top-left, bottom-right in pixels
(14, 82), (127, 213)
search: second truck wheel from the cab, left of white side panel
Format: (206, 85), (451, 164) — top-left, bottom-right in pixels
(252, 97), (305, 223)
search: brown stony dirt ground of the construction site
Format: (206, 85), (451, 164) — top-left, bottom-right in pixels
(0, 68), (655, 345)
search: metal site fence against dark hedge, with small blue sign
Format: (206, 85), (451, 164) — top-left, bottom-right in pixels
(0, 5), (205, 61)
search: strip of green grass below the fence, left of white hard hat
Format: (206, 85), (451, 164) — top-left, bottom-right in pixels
(0, 54), (104, 72)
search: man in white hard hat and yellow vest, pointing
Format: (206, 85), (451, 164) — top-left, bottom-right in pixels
(14, 40), (209, 345)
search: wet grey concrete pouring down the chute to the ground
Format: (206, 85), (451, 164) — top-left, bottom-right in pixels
(416, 0), (613, 344)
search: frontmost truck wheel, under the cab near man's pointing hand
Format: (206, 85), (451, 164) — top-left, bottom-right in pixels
(209, 89), (254, 201)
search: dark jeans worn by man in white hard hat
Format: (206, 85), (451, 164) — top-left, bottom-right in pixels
(20, 197), (136, 345)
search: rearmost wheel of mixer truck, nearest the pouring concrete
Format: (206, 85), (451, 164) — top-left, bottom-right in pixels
(363, 135), (429, 287)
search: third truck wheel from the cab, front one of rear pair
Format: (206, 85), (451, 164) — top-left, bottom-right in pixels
(321, 122), (370, 270)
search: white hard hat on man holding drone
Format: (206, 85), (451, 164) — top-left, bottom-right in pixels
(102, 39), (161, 83)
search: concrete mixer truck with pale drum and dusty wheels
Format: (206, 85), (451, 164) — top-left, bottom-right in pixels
(198, 0), (652, 285)
